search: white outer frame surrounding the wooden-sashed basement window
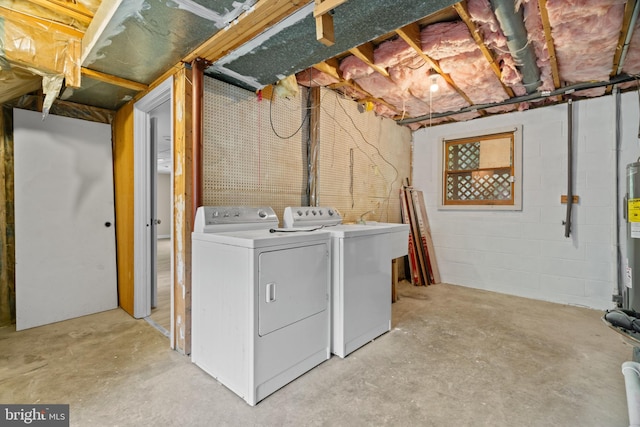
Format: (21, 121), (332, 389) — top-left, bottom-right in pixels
(438, 125), (522, 211)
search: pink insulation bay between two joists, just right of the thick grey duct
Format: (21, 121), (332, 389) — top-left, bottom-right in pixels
(547, 0), (625, 83)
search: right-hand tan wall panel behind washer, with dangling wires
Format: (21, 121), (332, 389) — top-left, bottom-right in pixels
(317, 89), (411, 226)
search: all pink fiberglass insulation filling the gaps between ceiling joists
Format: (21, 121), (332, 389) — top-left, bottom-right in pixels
(297, 0), (640, 129)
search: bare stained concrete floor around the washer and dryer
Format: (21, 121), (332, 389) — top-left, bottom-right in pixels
(0, 282), (632, 427)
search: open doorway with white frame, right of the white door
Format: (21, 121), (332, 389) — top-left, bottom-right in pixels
(134, 78), (174, 343)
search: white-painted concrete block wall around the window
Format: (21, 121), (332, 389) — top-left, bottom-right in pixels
(413, 92), (639, 309)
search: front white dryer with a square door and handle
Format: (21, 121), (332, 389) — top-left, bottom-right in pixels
(191, 207), (331, 405)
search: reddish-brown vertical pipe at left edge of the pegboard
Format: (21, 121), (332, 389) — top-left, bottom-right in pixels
(191, 58), (205, 231)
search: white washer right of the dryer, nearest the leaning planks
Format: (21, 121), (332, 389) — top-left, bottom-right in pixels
(283, 206), (409, 358)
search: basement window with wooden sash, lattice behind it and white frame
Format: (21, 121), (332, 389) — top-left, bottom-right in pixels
(441, 128), (522, 210)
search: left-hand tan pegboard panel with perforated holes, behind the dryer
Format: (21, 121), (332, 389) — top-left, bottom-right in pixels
(203, 77), (309, 219)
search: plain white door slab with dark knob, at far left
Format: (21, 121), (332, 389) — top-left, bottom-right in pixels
(14, 109), (118, 330)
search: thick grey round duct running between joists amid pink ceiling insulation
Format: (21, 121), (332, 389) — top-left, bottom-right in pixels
(491, 0), (541, 93)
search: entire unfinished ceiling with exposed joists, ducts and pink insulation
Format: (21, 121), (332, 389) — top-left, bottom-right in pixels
(0, 0), (640, 129)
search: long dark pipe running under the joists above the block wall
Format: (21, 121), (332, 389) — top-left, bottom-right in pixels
(396, 74), (636, 125)
